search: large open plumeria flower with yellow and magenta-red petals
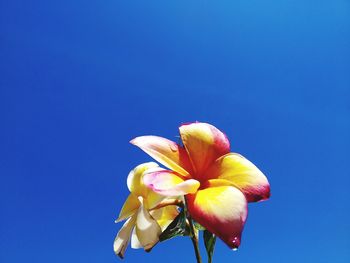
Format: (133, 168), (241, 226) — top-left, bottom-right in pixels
(131, 122), (270, 249)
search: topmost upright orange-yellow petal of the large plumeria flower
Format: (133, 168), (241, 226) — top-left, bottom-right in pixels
(179, 122), (230, 177)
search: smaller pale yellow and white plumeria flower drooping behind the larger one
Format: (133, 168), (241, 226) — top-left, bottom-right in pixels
(113, 162), (179, 258)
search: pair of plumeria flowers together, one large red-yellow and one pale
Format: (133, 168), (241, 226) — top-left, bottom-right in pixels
(114, 122), (270, 257)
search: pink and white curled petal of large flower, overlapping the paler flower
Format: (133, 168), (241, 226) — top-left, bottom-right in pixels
(143, 170), (200, 196)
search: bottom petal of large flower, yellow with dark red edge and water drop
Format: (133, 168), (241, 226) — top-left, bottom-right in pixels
(186, 186), (248, 249)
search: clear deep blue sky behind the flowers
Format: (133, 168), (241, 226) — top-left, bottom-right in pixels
(0, 0), (350, 263)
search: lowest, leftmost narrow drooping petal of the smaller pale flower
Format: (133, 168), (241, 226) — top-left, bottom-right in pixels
(113, 217), (136, 258)
